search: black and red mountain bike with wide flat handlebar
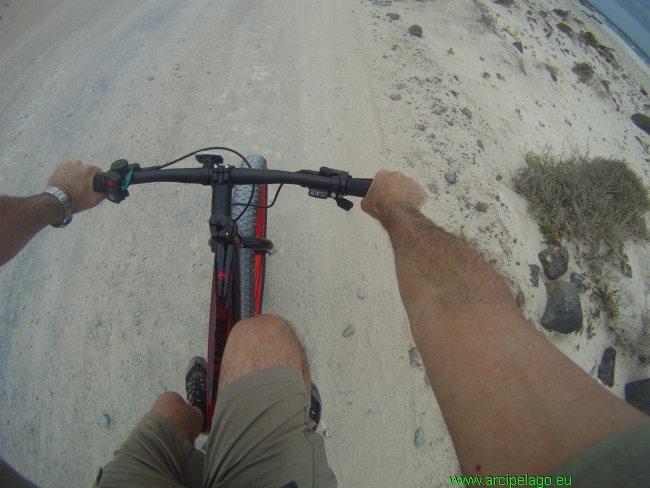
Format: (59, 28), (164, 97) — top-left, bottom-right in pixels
(93, 147), (372, 432)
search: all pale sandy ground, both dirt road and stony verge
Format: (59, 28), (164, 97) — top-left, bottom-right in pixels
(0, 0), (650, 487)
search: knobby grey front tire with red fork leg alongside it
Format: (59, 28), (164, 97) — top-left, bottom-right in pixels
(231, 154), (268, 319)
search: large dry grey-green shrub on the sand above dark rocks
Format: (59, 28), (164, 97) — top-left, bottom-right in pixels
(513, 149), (650, 319)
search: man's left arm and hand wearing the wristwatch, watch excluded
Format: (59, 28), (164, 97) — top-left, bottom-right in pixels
(0, 161), (105, 266)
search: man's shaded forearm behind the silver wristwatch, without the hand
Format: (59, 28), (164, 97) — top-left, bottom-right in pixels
(0, 195), (65, 266)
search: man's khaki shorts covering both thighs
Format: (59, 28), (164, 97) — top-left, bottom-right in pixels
(94, 366), (336, 488)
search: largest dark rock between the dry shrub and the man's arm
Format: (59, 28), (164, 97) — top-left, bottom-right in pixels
(540, 281), (582, 334)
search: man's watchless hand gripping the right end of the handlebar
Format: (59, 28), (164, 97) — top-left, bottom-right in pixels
(361, 169), (427, 221)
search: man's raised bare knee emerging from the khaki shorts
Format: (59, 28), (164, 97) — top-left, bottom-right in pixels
(218, 314), (311, 398)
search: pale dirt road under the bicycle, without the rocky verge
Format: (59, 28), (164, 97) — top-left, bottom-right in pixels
(0, 0), (458, 487)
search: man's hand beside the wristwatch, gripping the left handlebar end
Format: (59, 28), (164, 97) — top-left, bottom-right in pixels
(47, 160), (106, 214)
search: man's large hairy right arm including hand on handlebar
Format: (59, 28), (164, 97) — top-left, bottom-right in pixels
(362, 170), (650, 475)
